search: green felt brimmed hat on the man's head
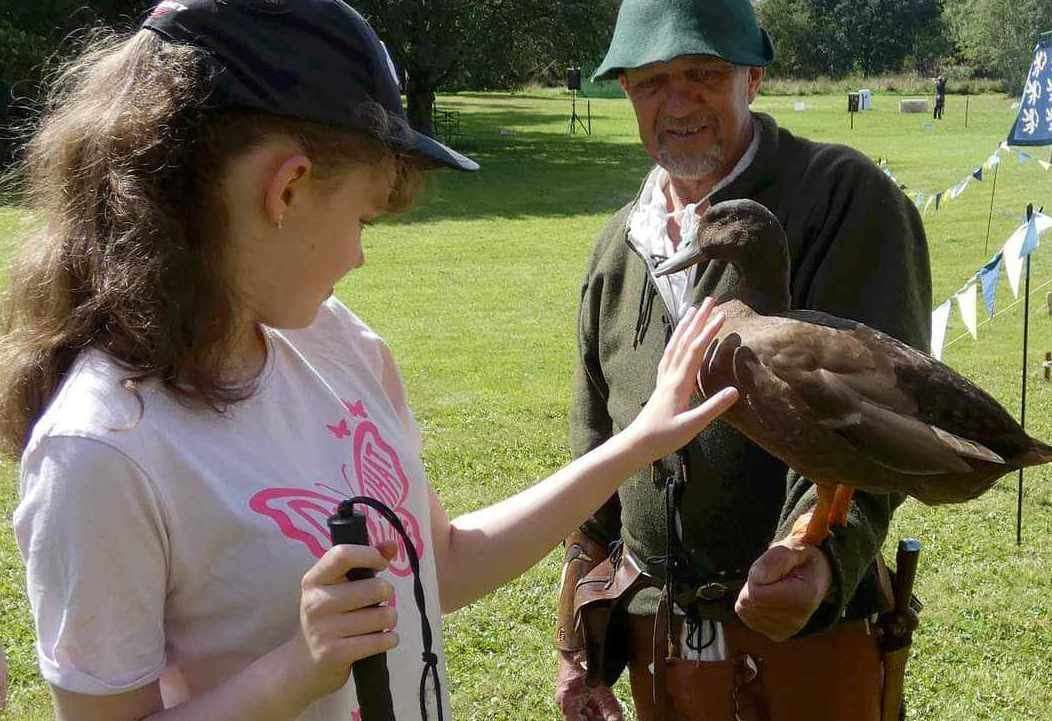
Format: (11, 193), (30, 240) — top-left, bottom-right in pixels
(592, 0), (774, 80)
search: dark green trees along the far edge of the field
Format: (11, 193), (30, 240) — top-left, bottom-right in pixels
(0, 0), (1052, 158)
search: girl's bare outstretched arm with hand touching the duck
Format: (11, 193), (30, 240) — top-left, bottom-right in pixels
(431, 300), (737, 613)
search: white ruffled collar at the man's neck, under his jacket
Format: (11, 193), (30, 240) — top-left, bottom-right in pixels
(628, 118), (761, 320)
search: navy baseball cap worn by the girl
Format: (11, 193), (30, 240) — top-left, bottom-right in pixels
(142, 0), (479, 171)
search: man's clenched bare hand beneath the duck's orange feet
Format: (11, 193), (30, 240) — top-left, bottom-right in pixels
(734, 537), (833, 641)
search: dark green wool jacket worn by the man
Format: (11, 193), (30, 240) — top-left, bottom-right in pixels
(570, 115), (931, 630)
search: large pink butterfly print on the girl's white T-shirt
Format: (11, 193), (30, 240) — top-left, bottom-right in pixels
(248, 421), (424, 577)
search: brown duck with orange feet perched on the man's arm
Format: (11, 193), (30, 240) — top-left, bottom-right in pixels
(655, 200), (1052, 544)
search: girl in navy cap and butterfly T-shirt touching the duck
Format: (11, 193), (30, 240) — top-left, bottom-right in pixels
(0, 0), (735, 721)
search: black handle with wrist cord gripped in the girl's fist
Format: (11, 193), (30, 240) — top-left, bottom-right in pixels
(328, 501), (396, 721)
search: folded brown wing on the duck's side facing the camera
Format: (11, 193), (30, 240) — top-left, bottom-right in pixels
(734, 319), (1004, 476)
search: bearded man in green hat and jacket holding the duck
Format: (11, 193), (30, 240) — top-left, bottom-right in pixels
(557, 0), (931, 721)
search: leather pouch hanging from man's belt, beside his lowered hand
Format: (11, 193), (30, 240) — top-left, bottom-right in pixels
(573, 554), (650, 686)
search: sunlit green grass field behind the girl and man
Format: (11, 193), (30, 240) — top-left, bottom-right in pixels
(0, 94), (1052, 721)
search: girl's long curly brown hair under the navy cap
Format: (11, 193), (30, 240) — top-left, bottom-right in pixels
(0, 31), (421, 455)
